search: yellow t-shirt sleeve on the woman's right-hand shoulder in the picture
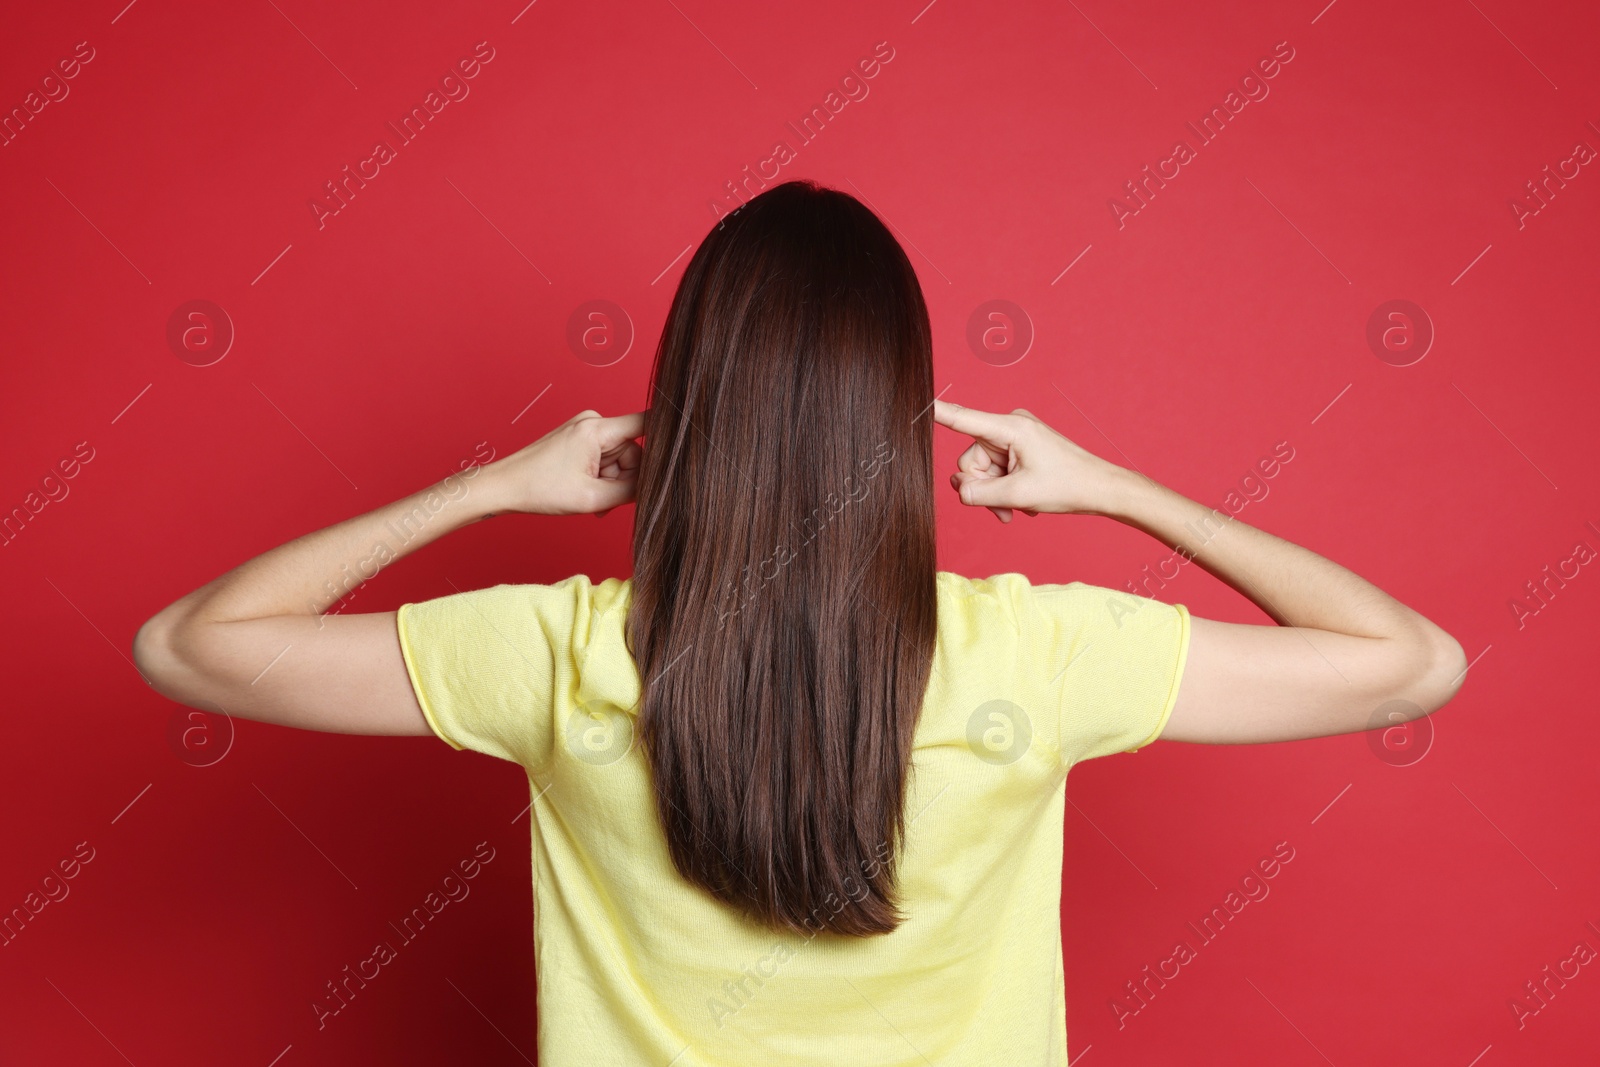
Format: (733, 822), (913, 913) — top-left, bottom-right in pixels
(1018, 582), (1189, 766)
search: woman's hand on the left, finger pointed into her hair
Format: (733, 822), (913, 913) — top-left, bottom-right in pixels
(483, 411), (645, 515)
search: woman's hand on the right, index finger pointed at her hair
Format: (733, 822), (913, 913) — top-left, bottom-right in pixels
(933, 400), (1130, 523)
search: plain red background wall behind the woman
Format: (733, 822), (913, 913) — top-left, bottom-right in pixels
(0, 0), (1600, 1067)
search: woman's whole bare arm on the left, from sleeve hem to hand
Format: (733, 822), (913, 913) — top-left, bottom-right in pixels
(133, 411), (643, 734)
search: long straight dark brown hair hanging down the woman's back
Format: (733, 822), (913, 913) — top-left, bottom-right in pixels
(629, 181), (938, 936)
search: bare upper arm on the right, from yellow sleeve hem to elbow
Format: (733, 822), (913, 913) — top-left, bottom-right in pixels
(1162, 617), (1466, 744)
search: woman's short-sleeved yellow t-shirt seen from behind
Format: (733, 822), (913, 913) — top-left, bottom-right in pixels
(398, 571), (1189, 1067)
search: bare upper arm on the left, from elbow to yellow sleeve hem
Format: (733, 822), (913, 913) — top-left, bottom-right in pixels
(133, 611), (432, 736)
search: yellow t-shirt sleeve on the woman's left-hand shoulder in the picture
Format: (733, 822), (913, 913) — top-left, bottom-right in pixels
(395, 574), (592, 769)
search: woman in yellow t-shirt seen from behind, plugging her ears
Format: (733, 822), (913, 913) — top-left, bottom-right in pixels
(134, 182), (1466, 1067)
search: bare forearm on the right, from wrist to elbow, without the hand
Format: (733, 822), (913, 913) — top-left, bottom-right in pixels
(1110, 472), (1450, 652)
